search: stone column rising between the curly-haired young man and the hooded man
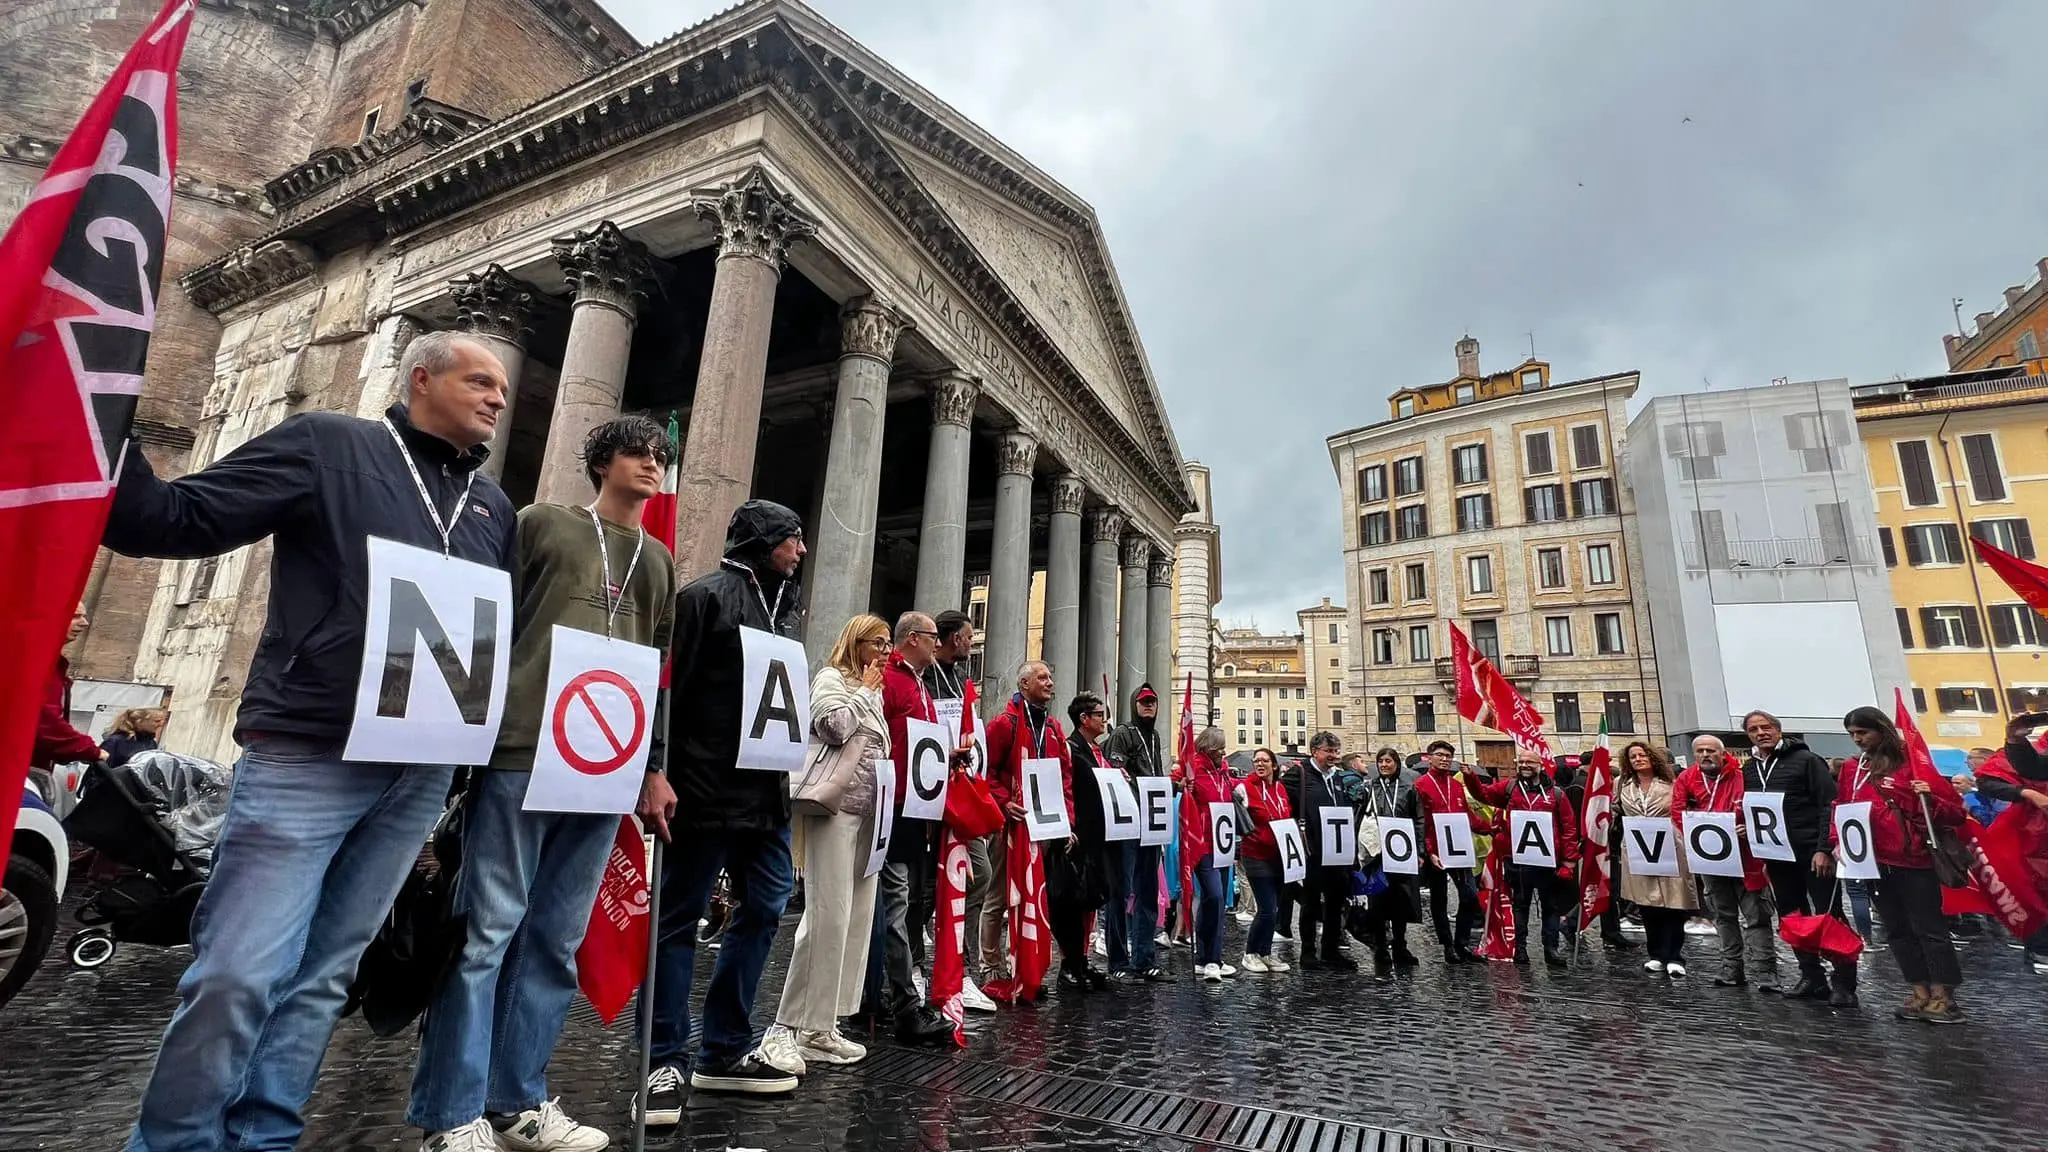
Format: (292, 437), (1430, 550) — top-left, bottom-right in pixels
(676, 168), (817, 582)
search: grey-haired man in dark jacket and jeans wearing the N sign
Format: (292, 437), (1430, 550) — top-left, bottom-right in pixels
(104, 332), (514, 1148)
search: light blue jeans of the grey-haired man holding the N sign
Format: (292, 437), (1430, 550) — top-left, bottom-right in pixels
(129, 736), (455, 1152)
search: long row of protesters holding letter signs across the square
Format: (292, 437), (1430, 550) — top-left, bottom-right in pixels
(64, 332), (2048, 1152)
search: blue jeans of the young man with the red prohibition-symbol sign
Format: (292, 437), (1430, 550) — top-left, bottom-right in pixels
(406, 771), (618, 1132)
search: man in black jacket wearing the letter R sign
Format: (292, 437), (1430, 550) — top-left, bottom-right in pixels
(1743, 711), (1855, 1006)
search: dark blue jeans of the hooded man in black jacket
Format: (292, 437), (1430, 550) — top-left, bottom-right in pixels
(641, 826), (795, 1068)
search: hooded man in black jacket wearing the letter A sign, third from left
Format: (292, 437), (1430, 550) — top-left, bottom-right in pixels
(639, 500), (809, 1125)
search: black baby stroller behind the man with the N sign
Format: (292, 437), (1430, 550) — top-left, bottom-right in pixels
(63, 752), (231, 968)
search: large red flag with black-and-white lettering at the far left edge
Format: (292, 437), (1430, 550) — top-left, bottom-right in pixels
(0, 0), (193, 842)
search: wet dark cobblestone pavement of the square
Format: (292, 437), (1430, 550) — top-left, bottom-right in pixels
(0, 924), (2048, 1152)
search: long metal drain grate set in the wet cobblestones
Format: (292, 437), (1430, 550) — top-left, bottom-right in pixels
(860, 1047), (1501, 1152)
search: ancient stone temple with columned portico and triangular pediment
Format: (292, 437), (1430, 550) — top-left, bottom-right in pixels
(0, 0), (1219, 758)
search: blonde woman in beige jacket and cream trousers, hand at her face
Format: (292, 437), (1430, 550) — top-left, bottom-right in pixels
(762, 615), (889, 1074)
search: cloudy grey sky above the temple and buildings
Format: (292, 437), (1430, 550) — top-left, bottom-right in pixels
(604, 0), (2048, 629)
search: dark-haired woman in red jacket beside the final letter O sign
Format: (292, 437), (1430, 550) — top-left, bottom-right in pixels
(1827, 705), (1966, 1025)
